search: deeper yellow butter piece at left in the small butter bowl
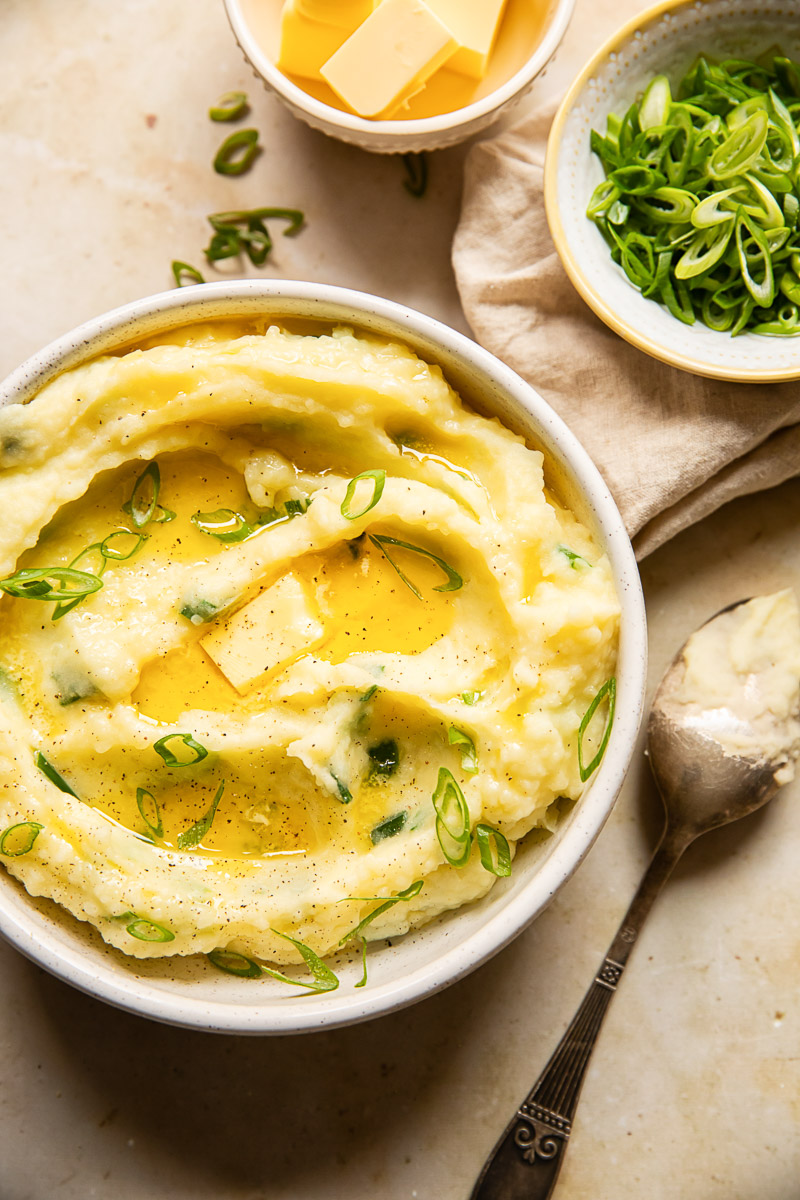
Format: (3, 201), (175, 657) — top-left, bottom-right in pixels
(278, 0), (378, 79)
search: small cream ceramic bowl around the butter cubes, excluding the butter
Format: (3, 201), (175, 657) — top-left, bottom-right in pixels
(224, 0), (575, 154)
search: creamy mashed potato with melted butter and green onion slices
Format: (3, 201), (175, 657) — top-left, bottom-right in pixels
(0, 324), (619, 962)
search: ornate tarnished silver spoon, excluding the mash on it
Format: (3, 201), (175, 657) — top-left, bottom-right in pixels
(470, 600), (796, 1200)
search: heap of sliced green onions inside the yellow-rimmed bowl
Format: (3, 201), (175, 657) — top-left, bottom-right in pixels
(587, 53), (800, 336)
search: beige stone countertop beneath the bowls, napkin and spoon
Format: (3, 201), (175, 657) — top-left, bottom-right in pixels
(0, 0), (800, 1200)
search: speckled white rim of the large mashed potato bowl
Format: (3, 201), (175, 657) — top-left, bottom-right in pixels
(0, 280), (646, 1034)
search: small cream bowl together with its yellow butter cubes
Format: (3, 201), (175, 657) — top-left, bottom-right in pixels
(224, 0), (575, 154)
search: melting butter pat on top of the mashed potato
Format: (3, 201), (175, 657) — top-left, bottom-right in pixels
(200, 572), (324, 691)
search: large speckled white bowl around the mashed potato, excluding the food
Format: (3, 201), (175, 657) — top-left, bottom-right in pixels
(0, 280), (646, 1033)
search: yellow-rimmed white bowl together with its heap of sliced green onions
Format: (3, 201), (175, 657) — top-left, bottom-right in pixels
(545, 0), (800, 383)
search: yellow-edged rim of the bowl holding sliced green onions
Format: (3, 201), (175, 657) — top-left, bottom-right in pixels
(545, 0), (800, 383)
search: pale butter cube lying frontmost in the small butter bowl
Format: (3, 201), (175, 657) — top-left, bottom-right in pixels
(320, 0), (458, 118)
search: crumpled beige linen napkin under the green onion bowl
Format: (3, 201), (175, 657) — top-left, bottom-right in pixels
(453, 110), (800, 558)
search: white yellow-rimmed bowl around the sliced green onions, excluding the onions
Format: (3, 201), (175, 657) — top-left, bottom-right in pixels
(545, 0), (800, 383)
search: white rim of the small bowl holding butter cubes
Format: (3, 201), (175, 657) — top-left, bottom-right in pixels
(224, 0), (576, 140)
